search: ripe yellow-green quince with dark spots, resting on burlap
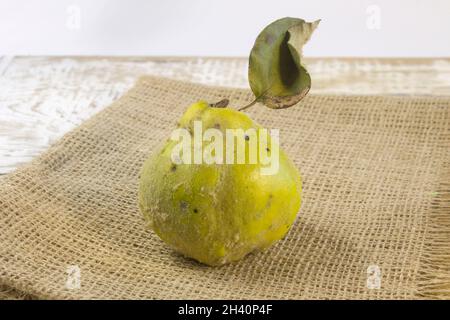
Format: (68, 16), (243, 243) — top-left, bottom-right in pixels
(139, 101), (301, 266)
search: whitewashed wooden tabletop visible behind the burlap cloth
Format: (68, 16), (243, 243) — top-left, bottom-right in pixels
(0, 57), (450, 174)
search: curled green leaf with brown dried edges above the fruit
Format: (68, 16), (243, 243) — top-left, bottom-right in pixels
(248, 18), (320, 109)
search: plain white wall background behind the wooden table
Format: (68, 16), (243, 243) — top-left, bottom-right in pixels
(0, 0), (450, 57)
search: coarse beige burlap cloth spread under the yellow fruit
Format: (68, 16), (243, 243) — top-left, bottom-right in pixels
(0, 77), (450, 299)
